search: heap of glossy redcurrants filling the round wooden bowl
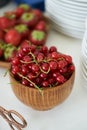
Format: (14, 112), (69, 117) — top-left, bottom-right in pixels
(10, 45), (75, 89)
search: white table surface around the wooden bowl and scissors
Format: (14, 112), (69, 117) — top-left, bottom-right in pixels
(0, 3), (87, 130)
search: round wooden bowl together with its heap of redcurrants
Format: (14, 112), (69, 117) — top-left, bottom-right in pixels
(9, 45), (75, 110)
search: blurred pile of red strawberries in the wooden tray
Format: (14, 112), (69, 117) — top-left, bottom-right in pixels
(0, 4), (48, 62)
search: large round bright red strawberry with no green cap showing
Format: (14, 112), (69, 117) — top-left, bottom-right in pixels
(5, 29), (21, 46)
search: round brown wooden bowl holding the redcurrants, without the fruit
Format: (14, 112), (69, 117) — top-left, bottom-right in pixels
(9, 72), (75, 110)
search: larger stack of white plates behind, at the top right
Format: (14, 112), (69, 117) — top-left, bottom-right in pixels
(45, 0), (87, 38)
